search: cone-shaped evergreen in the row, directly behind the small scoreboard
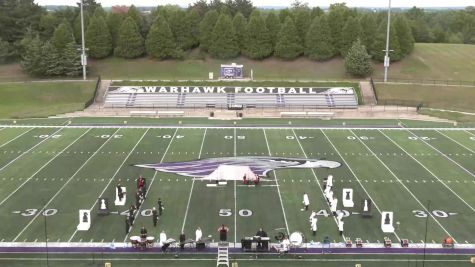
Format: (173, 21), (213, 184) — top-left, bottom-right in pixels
(209, 13), (239, 59)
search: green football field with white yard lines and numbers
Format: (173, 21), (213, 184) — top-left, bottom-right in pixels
(0, 123), (475, 251)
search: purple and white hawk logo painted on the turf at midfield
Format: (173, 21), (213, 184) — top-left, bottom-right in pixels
(134, 157), (341, 181)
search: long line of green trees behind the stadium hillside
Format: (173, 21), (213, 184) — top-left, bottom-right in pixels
(0, 0), (475, 76)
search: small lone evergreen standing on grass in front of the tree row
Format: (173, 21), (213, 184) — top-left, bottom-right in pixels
(345, 39), (373, 77)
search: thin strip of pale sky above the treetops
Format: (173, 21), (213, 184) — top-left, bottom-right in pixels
(35, 0), (475, 7)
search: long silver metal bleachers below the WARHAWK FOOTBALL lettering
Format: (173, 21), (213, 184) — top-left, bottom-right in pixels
(104, 87), (358, 108)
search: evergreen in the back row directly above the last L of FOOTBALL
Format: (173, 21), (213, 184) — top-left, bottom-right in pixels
(305, 15), (335, 61)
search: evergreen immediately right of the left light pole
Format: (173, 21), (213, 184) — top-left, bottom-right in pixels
(86, 15), (112, 58)
